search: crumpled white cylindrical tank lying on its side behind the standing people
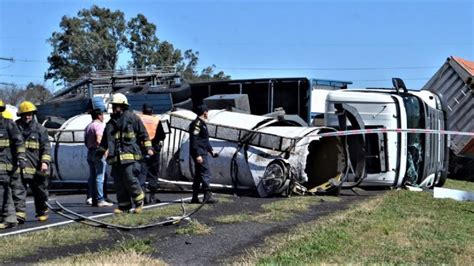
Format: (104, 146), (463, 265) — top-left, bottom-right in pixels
(52, 110), (346, 197)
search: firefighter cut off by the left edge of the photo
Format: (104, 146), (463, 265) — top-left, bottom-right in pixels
(0, 100), (26, 229)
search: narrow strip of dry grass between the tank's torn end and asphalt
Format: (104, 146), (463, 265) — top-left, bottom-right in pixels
(214, 196), (340, 223)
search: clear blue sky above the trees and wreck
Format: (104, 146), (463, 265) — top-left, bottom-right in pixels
(0, 0), (474, 91)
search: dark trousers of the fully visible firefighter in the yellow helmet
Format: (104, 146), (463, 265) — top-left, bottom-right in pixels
(22, 174), (48, 216)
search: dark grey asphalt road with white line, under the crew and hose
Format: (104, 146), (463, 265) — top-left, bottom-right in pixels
(2, 190), (383, 265)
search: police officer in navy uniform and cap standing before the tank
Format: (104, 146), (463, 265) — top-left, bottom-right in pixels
(189, 105), (218, 203)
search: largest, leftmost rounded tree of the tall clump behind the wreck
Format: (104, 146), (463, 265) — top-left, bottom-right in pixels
(45, 5), (126, 82)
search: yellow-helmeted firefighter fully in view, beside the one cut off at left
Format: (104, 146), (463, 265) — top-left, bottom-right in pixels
(13, 101), (51, 223)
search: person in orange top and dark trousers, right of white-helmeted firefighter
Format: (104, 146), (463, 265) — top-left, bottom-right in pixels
(138, 103), (166, 204)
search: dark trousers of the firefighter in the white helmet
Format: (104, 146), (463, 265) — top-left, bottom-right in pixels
(112, 162), (145, 211)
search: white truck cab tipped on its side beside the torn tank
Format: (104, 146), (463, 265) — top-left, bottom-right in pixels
(312, 78), (448, 187)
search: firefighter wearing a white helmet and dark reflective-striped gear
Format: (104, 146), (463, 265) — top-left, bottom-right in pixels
(98, 93), (154, 214)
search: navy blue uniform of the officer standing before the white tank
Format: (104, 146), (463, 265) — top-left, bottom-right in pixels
(189, 117), (213, 191)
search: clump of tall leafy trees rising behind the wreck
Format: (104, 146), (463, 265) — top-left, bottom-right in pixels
(45, 5), (230, 83)
